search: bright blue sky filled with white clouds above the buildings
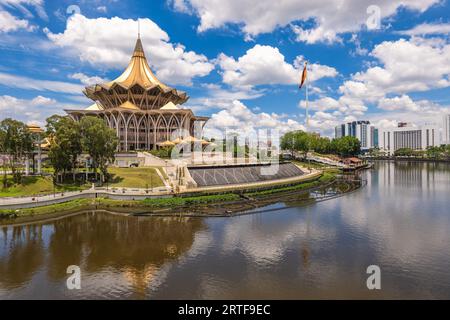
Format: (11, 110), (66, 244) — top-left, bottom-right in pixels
(0, 0), (450, 137)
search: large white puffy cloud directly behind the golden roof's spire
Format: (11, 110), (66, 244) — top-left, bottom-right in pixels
(45, 14), (214, 85)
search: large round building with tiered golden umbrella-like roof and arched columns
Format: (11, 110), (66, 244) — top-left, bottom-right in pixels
(65, 37), (209, 151)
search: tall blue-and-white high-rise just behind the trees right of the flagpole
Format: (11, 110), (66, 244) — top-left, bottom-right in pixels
(334, 120), (378, 150)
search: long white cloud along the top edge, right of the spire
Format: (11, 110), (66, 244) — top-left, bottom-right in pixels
(172, 0), (439, 43)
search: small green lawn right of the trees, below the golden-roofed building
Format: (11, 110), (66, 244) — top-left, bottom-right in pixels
(108, 167), (164, 188)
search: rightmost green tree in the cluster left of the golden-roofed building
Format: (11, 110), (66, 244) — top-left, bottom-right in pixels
(80, 116), (118, 181)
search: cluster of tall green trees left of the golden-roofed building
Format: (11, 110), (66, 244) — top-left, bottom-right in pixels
(0, 115), (118, 188)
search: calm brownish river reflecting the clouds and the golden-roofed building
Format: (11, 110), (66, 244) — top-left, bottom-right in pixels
(0, 162), (450, 299)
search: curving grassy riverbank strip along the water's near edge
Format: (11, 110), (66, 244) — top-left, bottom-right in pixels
(0, 171), (337, 224)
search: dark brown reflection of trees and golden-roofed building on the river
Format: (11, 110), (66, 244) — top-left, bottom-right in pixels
(0, 213), (204, 297)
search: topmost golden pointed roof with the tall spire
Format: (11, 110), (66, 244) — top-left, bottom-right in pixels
(105, 38), (168, 89)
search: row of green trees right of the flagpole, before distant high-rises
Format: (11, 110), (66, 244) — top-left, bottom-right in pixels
(280, 130), (361, 157)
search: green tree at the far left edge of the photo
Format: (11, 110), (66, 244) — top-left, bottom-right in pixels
(0, 118), (33, 183)
